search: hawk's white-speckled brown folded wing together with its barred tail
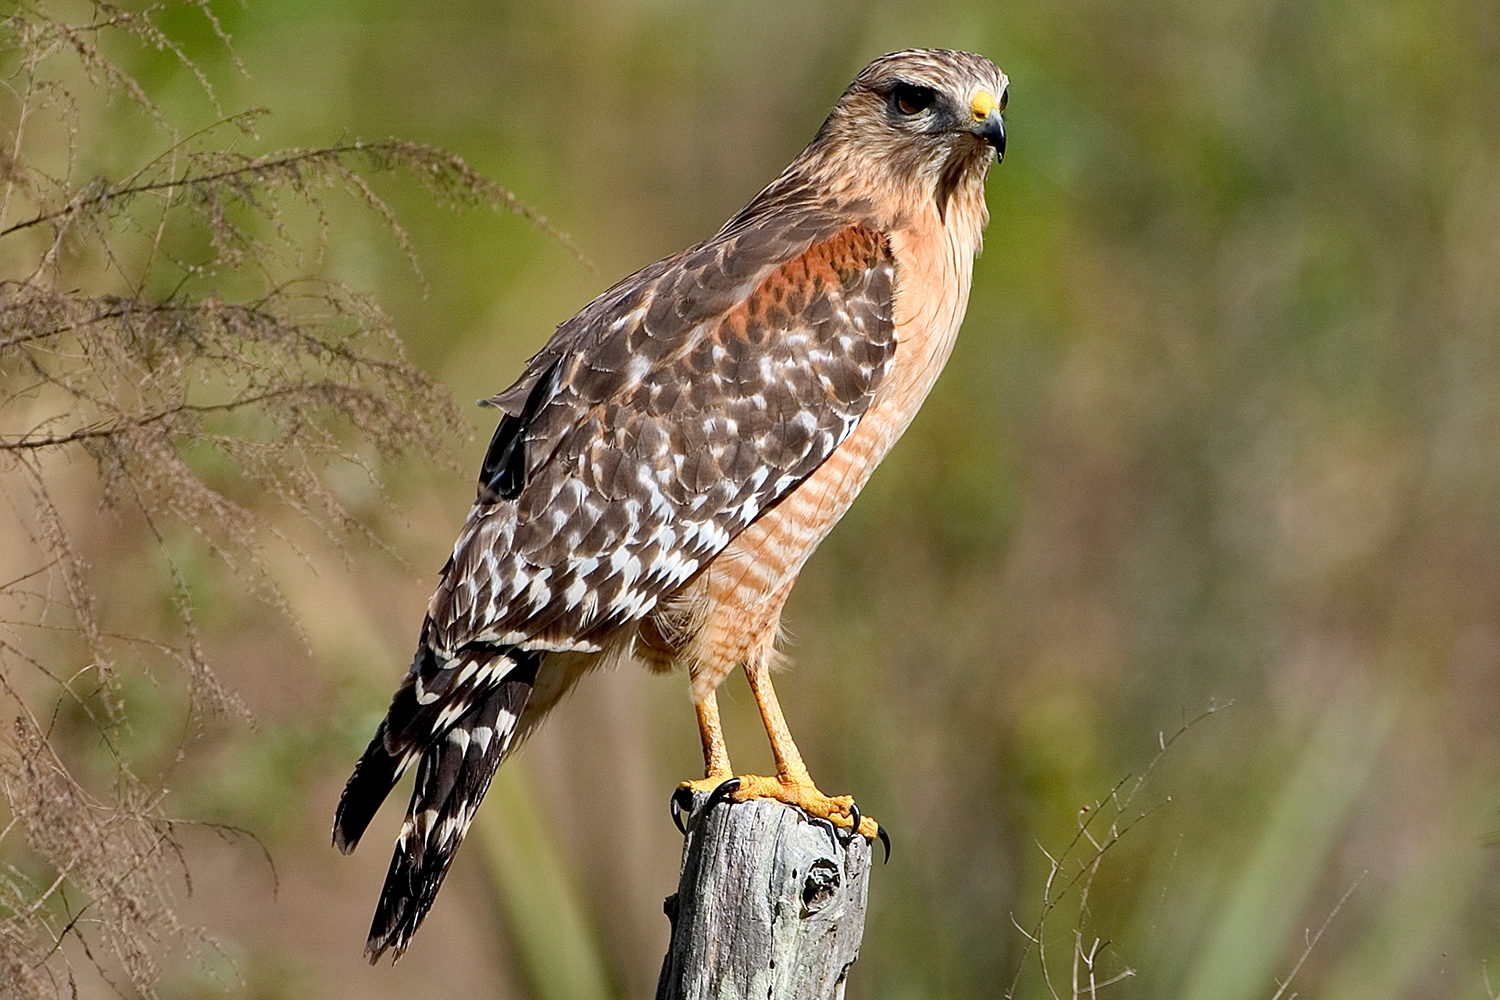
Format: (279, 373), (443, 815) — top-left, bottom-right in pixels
(333, 213), (896, 958)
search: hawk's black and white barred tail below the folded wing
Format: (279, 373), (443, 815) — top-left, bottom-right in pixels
(333, 645), (542, 964)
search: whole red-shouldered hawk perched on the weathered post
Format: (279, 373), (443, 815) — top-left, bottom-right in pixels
(333, 49), (1007, 963)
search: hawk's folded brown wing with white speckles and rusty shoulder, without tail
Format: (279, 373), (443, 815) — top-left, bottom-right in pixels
(428, 220), (896, 656)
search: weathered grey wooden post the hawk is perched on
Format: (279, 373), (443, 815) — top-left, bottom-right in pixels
(657, 795), (870, 1000)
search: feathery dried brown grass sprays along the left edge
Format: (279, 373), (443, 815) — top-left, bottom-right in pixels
(0, 0), (567, 997)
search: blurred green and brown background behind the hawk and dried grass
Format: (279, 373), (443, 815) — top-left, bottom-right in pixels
(0, 0), (1500, 1000)
